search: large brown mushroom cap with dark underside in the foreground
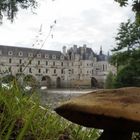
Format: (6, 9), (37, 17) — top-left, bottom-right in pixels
(55, 87), (140, 131)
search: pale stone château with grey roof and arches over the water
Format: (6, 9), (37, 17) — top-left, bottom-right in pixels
(0, 45), (115, 87)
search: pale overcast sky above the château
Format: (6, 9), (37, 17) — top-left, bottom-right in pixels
(0, 0), (133, 52)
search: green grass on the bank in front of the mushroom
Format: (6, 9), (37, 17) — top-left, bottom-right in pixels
(0, 83), (99, 140)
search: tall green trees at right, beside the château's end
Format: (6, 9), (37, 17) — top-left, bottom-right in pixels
(111, 21), (140, 87)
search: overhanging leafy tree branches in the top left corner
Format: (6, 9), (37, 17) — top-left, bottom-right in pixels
(0, 0), (37, 23)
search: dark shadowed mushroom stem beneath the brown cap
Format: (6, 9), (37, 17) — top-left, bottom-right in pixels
(98, 130), (132, 140)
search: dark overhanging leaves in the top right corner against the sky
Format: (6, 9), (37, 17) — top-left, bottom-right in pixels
(115, 0), (140, 24)
